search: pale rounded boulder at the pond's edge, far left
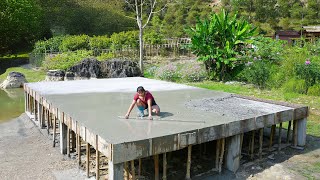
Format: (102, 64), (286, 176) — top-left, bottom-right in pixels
(0, 72), (27, 89)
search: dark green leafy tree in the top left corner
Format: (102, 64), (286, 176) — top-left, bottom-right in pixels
(0, 0), (45, 54)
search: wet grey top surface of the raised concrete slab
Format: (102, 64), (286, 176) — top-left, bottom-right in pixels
(27, 77), (292, 144)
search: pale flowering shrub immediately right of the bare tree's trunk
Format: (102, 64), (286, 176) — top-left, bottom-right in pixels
(155, 63), (180, 81)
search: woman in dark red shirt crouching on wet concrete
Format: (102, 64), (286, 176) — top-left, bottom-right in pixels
(125, 86), (160, 120)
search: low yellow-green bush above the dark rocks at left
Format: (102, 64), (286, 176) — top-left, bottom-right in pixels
(43, 50), (93, 70)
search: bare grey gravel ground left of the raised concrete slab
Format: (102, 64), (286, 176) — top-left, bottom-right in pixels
(0, 114), (85, 180)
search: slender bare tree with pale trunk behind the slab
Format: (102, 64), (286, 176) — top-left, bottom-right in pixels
(125, 0), (168, 73)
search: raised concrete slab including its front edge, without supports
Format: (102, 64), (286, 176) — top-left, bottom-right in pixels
(25, 77), (307, 164)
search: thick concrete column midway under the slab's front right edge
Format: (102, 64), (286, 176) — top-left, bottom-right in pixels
(225, 134), (241, 172)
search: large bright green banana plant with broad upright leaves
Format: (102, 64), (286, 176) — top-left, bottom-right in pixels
(186, 10), (257, 81)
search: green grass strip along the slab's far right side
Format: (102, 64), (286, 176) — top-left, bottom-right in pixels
(188, 81), (320, 137)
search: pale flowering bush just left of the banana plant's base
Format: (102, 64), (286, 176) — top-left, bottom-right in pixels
(180, 63), (207, 82)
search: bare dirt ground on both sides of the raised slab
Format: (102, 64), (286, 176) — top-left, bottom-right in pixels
(0, 114), (320, 180)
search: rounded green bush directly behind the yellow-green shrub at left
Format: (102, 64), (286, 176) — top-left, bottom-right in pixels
(59, 35), (90, 52)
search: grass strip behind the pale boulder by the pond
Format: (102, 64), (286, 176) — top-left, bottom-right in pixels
(0, 67), (46, 82)
